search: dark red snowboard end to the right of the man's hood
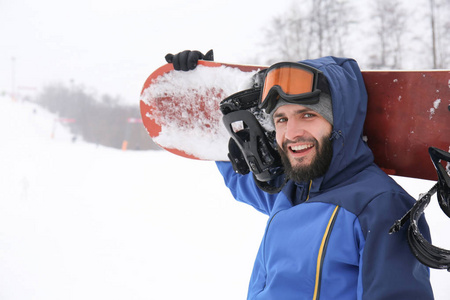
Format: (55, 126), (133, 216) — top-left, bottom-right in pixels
(362, 71), (450, 180)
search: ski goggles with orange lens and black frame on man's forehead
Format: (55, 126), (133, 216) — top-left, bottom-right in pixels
(259, 62), (330, 113)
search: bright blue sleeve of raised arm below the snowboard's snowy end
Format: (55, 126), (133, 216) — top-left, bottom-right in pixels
(216, 161), (276, 215)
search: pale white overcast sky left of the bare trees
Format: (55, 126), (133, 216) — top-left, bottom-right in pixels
(0, 0), (292, 103)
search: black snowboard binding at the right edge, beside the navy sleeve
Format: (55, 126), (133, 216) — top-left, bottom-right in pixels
(389, 147), (450, 272)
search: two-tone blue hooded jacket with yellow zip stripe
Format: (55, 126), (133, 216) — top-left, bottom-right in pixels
(217, 57), (433, 300)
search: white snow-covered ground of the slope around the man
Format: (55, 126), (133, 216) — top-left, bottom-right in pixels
(0, 97), (450, 300)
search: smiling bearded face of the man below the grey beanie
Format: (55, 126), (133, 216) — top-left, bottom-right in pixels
(273, 104), (333, 182)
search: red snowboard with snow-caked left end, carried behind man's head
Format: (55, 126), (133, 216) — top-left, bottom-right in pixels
(140, 61), (450, 180)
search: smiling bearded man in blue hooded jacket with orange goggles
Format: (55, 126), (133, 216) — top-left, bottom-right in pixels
(164, 52), (433, 300)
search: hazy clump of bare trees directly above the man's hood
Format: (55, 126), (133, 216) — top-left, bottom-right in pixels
(263, 0), (352, 63)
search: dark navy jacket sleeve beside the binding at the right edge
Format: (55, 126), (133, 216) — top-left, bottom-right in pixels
(358, 191), (433, 300)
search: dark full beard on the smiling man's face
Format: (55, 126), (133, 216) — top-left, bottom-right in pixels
(278, 135), (333, 182)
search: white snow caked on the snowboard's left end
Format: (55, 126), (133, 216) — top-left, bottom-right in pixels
(142, 66), (256, 160)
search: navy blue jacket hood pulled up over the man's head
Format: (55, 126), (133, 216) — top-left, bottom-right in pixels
(301, 56), (373, 191)
